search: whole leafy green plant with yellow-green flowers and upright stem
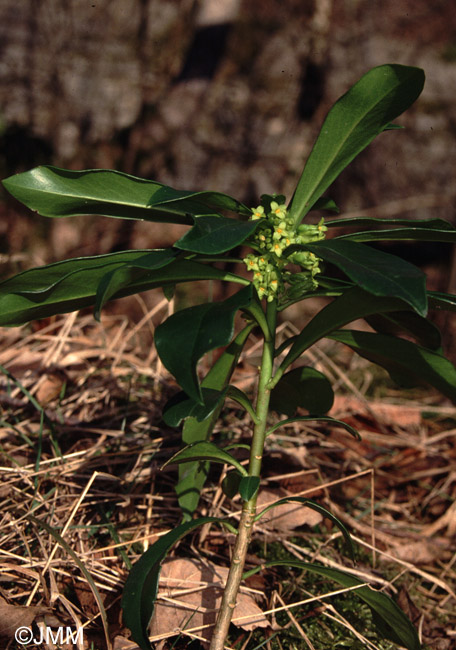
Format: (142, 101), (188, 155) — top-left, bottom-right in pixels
(0, 65), (456, 650)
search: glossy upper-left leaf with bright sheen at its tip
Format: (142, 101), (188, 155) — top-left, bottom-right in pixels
(3, 166), (251, 224)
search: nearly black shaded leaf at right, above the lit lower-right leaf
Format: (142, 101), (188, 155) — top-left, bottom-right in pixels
(366, 311), (442, 352)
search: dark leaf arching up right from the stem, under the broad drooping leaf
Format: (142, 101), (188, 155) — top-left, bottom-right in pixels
(278, 287), (410, 376)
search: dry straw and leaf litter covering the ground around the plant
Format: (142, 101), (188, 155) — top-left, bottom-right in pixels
(0, 303), (456, 650)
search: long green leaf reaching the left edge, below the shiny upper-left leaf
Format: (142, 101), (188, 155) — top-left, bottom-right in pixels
(0, 250), (250, 327)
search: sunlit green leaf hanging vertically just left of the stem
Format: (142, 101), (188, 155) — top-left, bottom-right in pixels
(175, 323), (254, 521)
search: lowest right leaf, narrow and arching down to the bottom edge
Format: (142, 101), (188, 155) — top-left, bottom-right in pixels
(243, 559), (421, 650)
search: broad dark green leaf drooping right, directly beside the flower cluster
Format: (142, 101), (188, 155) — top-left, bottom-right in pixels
(303, 239), (427, 316)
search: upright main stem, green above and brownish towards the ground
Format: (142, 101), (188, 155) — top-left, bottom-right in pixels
(210, 301), (277, 650)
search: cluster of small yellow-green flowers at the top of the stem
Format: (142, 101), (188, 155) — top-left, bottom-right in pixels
(244, 195), (327, 302)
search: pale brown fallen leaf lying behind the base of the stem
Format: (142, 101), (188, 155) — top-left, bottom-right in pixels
(150, 558), (269, 640)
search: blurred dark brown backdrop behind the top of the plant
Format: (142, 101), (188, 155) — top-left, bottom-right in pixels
(0, 0), (456, 306)
